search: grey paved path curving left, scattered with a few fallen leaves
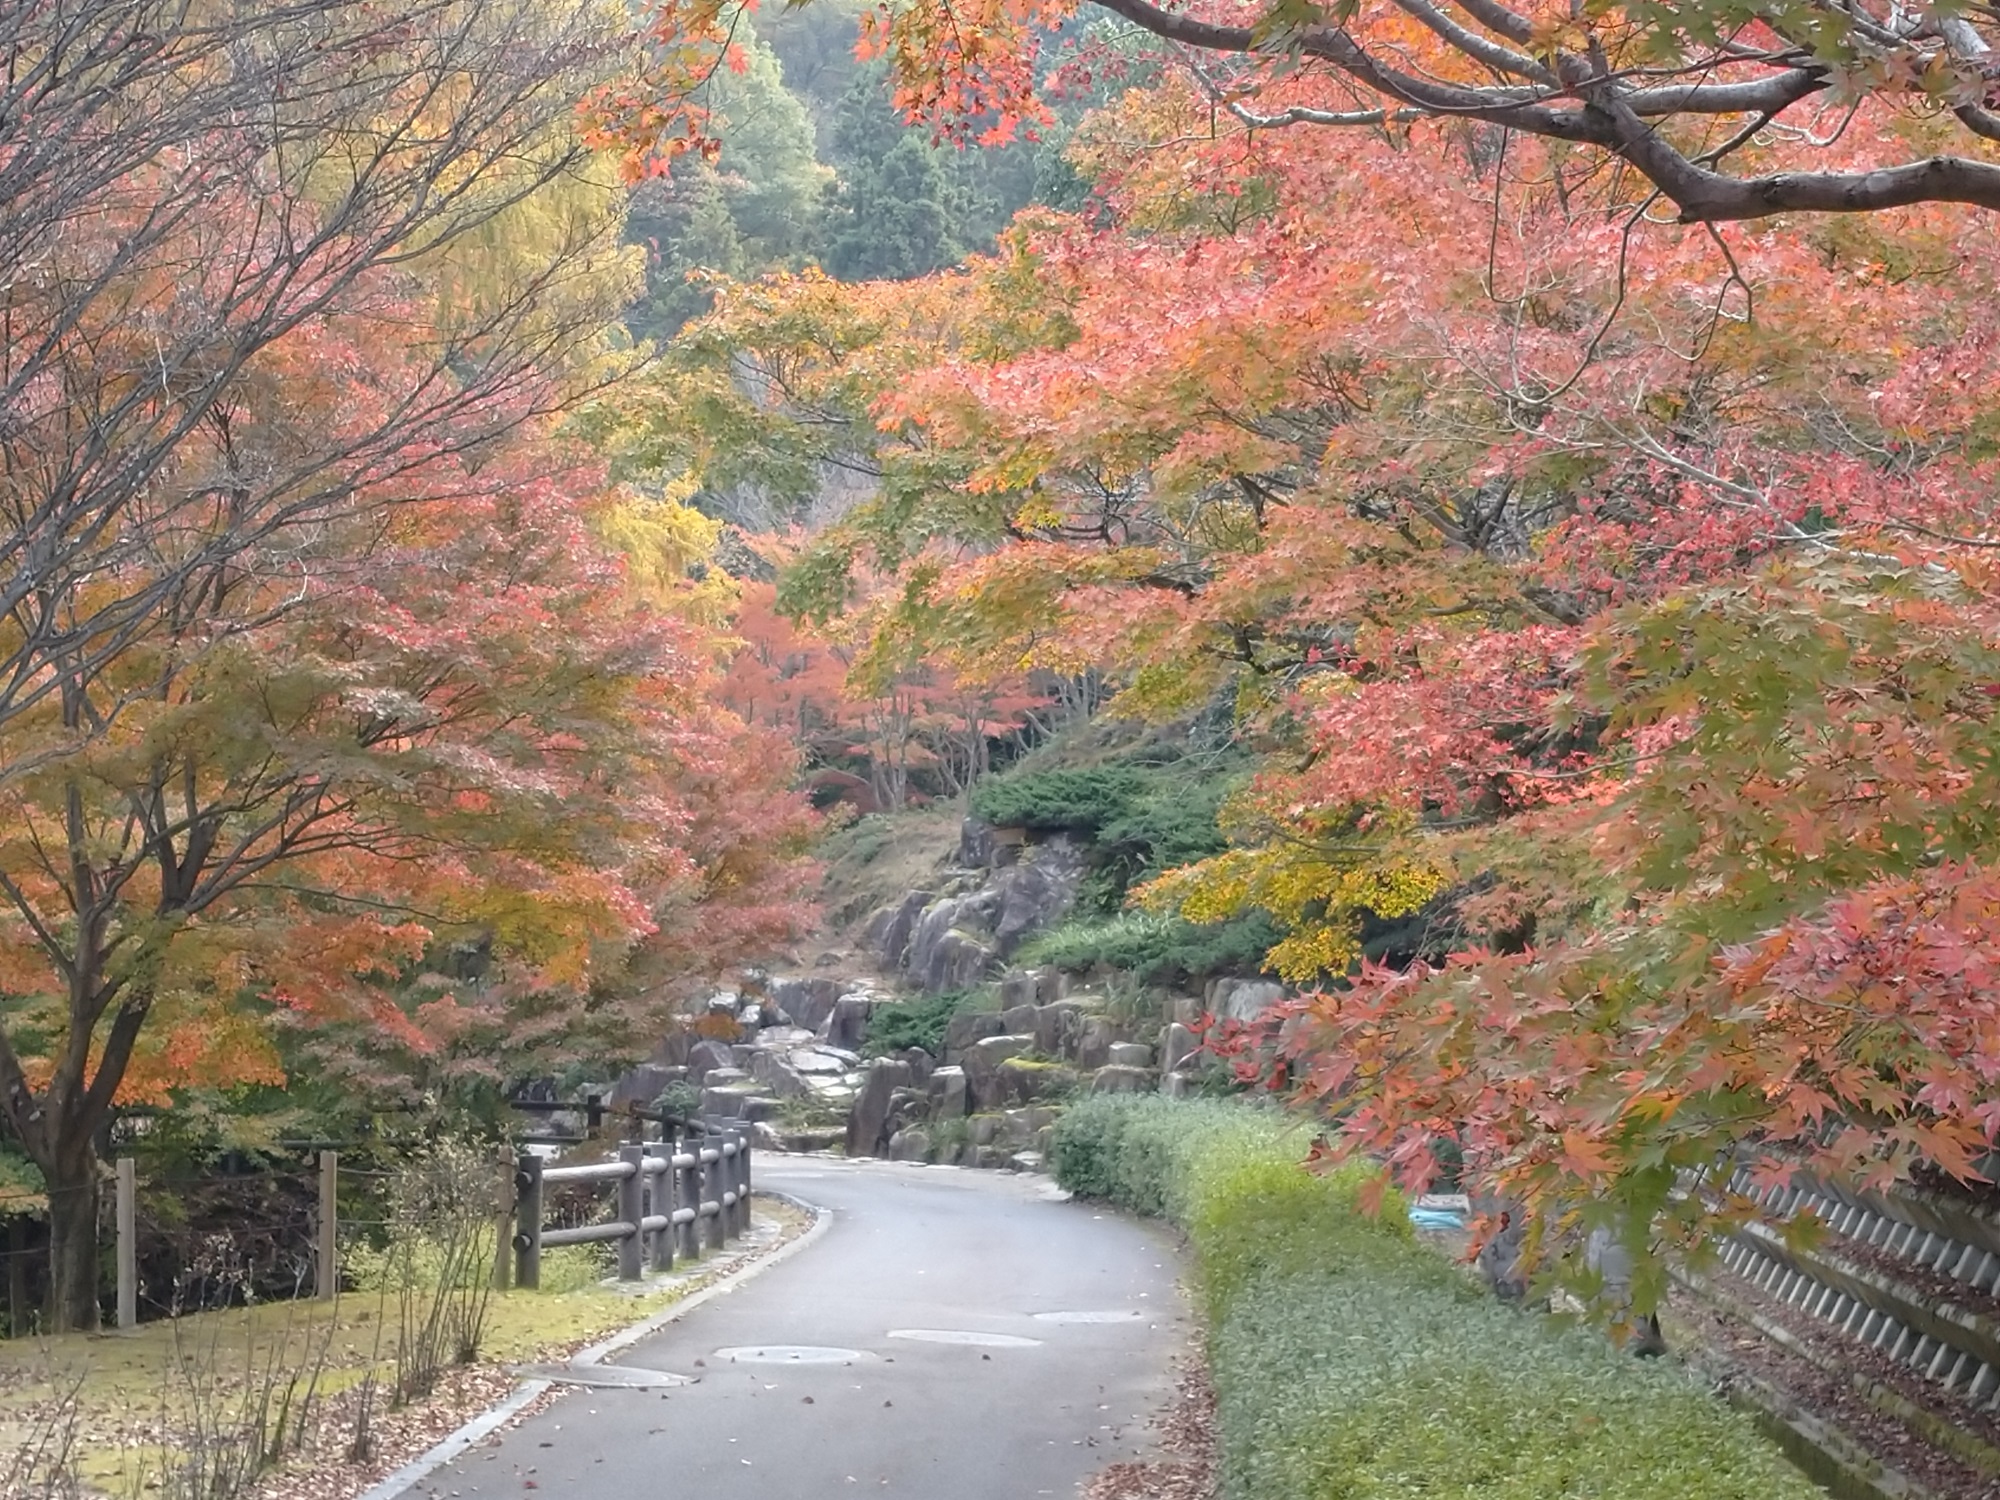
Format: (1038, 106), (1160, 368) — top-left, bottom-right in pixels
(404, 1156), (1188, 1500)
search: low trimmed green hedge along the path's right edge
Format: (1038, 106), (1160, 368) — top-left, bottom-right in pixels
(1050, 1096), (1820, 1500)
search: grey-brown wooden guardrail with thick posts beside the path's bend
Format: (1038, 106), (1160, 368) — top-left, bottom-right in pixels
(514, 1122), (750, 1288)
